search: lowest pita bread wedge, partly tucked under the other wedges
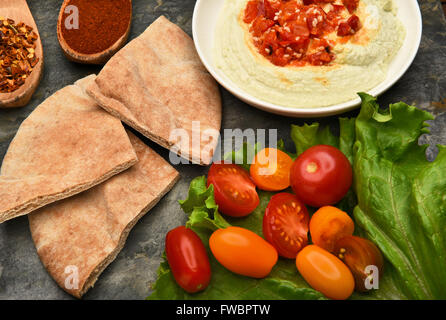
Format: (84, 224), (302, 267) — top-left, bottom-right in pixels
(28, 134), (179, 298)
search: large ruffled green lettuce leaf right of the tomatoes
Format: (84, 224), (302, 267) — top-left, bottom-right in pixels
(353, 94), (446, 299)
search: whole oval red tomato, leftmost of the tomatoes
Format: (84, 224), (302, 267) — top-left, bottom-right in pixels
(166, 226), (211, 293)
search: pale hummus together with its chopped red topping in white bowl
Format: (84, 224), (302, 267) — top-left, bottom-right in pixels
(213, 0), (406, 109)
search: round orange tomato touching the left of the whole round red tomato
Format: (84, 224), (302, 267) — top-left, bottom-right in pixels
(250, 148), (293, 191)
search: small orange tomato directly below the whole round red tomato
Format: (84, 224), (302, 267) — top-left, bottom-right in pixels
(310, 206), (355, 252)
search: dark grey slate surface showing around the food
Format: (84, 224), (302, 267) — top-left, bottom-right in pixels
(0, 0), (446, 299)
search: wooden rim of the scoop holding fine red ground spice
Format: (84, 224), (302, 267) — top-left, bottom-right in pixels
(57, 0), (132, 64)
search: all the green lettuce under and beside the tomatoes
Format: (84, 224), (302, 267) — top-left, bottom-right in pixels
(148, 94), (446, 300)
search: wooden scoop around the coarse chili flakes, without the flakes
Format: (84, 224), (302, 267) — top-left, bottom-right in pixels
(0, 0), (43, 108)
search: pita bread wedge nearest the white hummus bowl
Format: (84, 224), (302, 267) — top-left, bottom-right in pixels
(87, 16), (221, 165)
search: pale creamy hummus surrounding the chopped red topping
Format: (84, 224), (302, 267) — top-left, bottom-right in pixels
(213, 0), (405, 108)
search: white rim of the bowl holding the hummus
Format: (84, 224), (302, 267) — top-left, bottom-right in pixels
(192, 0), (423, 117)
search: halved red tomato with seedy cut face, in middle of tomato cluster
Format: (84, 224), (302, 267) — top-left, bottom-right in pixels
(263, 193), (310, 259)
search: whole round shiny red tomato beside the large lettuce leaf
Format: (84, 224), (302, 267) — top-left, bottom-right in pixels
(290, 145), (353, 207)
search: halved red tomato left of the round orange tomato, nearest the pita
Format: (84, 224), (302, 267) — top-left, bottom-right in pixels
(207, 163), (260, 217)
